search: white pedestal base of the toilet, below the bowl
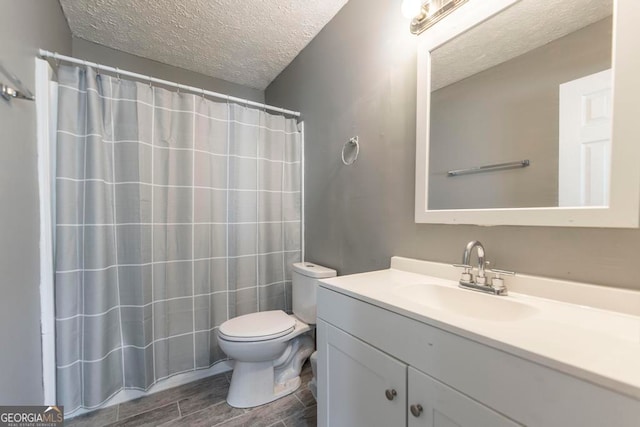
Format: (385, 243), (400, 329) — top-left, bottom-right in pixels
(227, 335), (313, 408)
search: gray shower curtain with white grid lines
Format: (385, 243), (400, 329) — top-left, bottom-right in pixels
(55, 66), (302, 413)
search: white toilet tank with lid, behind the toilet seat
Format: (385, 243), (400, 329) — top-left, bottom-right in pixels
(291, 262), (336, 324)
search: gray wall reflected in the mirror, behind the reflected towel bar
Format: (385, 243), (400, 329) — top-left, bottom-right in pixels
(429, 18), (612, 209)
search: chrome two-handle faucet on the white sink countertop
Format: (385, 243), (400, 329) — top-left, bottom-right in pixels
(454, 240), (515, 295)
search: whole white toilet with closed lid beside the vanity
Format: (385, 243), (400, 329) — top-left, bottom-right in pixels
(218, 262), (336, 408)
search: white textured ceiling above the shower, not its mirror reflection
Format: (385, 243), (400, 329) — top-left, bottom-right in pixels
(60, 0), (347, 89)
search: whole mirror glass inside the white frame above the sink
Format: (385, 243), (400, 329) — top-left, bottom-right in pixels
(428, 0), (613, 210)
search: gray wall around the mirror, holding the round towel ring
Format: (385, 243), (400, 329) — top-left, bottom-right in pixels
(266, 0), (640, 289)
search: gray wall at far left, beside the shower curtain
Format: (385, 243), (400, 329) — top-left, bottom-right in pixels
(0, 0), (71, 405)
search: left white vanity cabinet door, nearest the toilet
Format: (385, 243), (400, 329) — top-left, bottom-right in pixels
(318, 321), (407, 427)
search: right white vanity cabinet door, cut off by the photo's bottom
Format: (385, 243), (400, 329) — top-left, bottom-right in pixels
(408, 367), (519, 427)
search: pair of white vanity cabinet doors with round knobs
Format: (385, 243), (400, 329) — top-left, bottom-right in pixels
(317, 321), (517, 427)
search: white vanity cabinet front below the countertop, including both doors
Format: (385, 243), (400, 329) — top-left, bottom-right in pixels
(317, 285), (640, 427)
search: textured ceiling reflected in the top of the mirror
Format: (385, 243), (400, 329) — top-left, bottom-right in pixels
(431, 0), (613, 90)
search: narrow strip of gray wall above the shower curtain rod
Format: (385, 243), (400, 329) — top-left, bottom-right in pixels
(71, 37), (264, 102)
